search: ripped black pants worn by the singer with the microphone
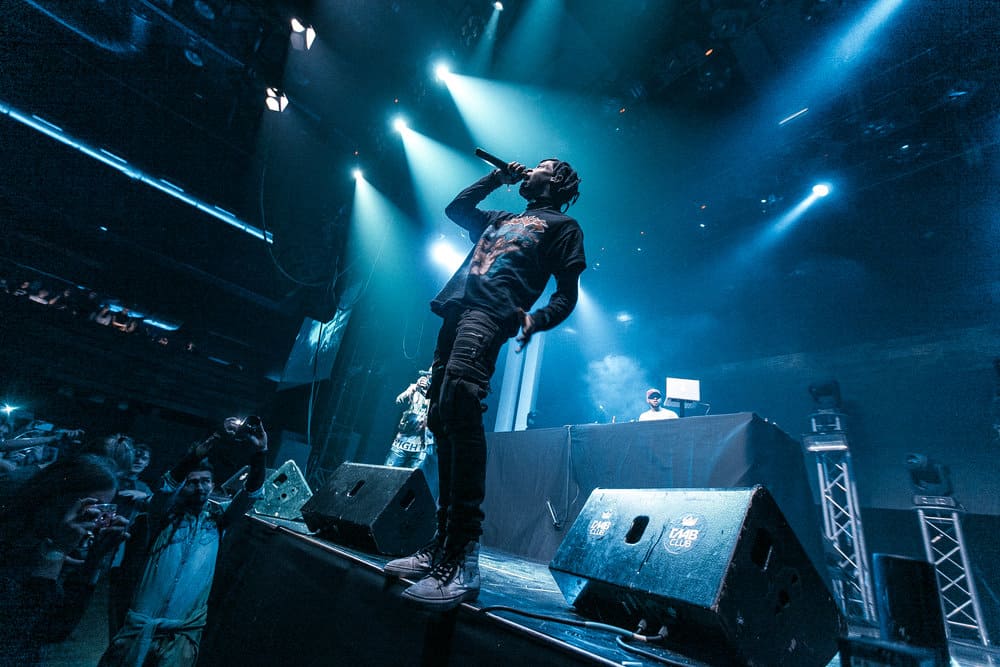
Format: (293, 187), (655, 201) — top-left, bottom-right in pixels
(427, 310), (516, 548)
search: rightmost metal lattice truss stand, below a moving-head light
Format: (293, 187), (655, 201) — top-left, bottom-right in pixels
(913, 496), (990, 646)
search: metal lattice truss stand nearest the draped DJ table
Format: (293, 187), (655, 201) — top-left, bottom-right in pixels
(803, 426), (877, 625)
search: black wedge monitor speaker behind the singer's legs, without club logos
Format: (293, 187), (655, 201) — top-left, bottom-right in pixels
(302, 461), (435, 556)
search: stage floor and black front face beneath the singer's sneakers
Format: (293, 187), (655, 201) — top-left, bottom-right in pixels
(200, 516), (1000, 667)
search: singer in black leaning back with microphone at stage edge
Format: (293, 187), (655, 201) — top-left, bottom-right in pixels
(385, 159), (586, 610)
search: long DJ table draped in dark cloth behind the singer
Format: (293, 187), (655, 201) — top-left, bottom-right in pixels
(483, 412), (827, 578)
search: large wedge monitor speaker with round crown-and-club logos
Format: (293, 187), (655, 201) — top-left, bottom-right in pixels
(549, 486), (842, 667)
